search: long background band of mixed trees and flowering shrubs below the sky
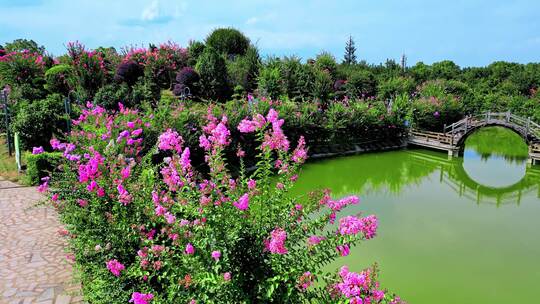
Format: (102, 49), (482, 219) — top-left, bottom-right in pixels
(0, 28), (540, 157)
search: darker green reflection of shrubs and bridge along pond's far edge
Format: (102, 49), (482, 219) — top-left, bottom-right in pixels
(295, 127), (540, 205)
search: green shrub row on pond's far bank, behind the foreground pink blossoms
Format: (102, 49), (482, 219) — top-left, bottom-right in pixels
(143, 96), (405, 180)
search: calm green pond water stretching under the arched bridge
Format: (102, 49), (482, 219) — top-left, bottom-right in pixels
(293, 128), (540, 304)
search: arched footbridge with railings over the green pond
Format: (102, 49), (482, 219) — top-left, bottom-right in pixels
(408, 112), (540, 164)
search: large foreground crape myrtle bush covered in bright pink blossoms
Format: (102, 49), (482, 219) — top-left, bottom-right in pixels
(39, 104), (401, 304)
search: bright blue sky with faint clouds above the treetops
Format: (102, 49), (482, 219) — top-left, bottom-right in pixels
(0, 0), (540, 66)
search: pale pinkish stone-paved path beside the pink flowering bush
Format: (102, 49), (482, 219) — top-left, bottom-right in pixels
(0, 180), (81, 304)
